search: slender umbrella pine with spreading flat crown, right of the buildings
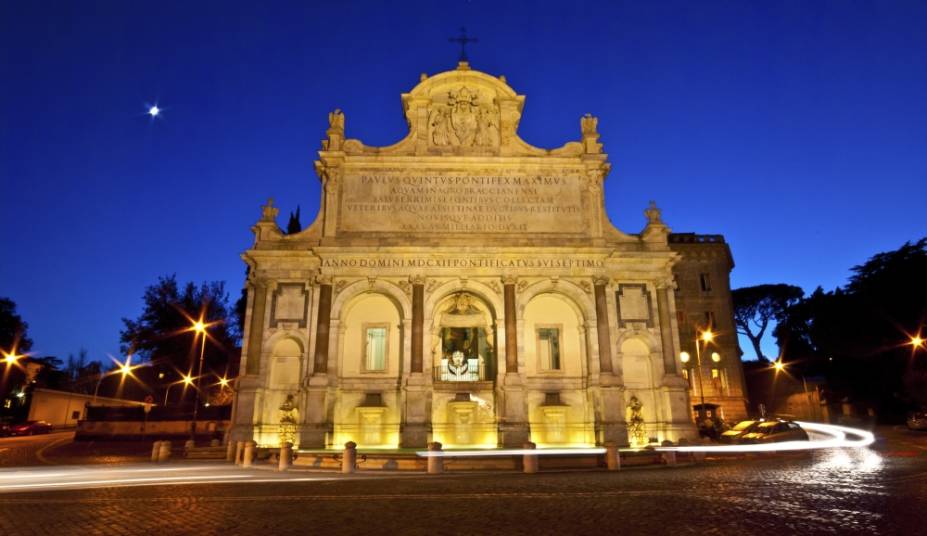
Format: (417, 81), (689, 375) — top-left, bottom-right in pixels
(732, 283), (804, 361)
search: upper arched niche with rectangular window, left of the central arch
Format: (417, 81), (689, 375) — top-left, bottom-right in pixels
(339, 291), (402, 377)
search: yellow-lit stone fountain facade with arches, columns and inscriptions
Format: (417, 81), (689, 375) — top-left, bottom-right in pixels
(232, 63), (739, 449)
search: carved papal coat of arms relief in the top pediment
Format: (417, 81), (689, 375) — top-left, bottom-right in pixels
(428, 87), (499, 147)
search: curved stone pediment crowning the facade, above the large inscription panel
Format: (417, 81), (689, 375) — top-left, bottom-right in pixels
(334, 63), (588, 156)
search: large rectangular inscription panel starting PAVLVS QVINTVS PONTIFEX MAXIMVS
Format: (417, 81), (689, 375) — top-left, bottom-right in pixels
(340, 173), (583, 233)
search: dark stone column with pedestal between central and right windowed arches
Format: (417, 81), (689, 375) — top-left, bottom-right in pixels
(499, 277), (529, 447)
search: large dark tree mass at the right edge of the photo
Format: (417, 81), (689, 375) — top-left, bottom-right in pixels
(776, 239), (927, 420)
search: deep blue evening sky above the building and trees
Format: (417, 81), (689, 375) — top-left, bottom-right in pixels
(0, 0), (927, 364)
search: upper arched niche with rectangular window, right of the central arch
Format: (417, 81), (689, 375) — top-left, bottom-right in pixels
(522, 292), (585, 377)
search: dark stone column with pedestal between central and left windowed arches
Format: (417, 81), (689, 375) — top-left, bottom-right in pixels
(400, 275), (431, 448)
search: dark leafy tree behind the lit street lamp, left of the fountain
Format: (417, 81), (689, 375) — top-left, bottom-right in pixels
(120, 275), (240, 406)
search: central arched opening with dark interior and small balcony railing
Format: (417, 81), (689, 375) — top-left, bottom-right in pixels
(430, 290), (498, 383)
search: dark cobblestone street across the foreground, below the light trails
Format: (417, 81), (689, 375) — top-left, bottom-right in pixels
(0, 449), (927, 535)
